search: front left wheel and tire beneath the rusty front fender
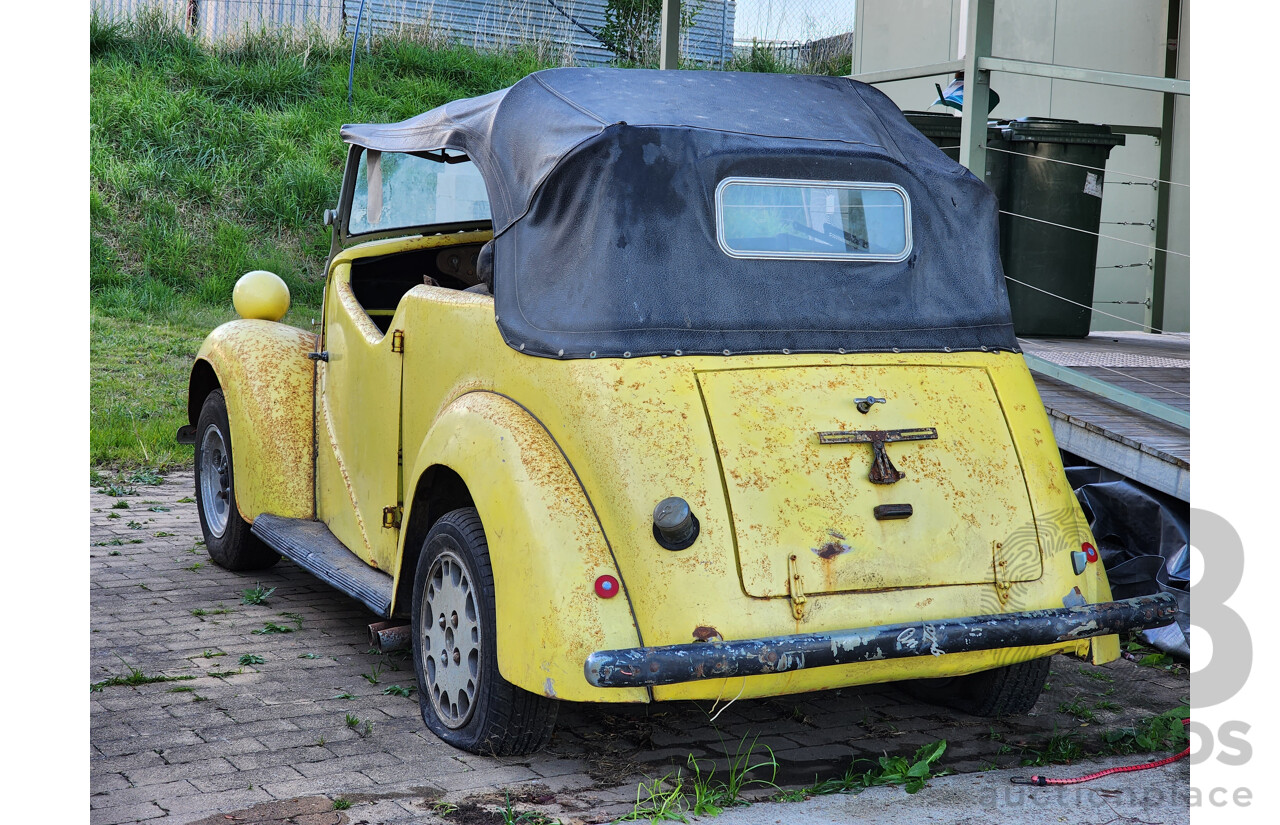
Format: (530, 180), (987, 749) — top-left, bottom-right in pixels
(196, 389), (280, 570)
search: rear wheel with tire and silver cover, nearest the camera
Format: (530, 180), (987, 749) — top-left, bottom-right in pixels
(411, 507), (557, 756)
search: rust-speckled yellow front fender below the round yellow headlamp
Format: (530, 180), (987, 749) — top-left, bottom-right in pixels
(187, 320), (316, 522)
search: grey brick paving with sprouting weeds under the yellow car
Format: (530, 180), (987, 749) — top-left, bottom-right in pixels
(90, 473), (1190, 825)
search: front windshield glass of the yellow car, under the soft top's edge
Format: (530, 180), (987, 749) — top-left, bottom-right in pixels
(347, 151), (490, 235)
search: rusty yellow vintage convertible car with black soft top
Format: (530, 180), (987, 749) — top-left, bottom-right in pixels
(179, 69), (1174, 753)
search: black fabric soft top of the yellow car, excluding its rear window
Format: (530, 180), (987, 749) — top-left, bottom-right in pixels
(342, 68), (1016, 358)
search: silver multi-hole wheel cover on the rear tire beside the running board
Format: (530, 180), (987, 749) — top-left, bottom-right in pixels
(417, 550), (481, 728)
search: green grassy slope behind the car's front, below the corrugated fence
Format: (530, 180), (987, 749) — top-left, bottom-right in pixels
(90, 17), (549, 469)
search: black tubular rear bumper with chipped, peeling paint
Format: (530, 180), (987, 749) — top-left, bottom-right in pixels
(586, 593), (1178, 687)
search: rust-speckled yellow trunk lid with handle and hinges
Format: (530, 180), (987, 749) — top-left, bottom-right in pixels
(698, 366), (1042, 596)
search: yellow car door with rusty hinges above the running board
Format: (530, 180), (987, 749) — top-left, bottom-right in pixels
(316, 262), (403, 569)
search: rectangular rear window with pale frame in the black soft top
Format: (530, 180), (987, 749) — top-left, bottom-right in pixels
(716, 178), (911, 261)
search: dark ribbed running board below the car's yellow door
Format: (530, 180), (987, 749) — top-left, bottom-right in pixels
(252, 514), (394, 618)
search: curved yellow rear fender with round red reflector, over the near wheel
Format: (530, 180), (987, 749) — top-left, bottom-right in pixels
(393, 390), (648, 702)
